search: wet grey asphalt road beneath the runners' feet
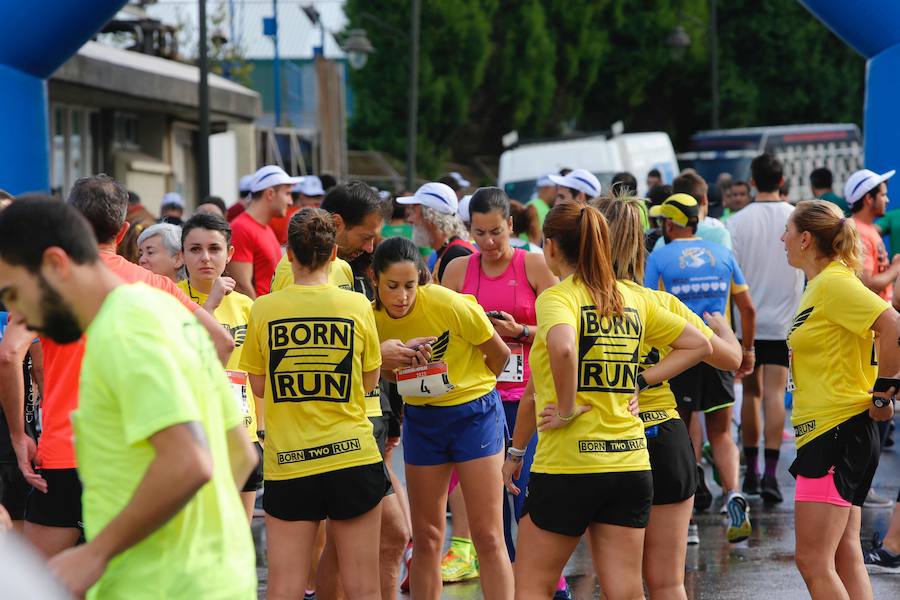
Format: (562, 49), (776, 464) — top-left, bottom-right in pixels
(254, 417), (900, 600)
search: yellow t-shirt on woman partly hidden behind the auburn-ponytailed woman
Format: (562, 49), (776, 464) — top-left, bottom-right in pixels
(622, 281), (715, 427)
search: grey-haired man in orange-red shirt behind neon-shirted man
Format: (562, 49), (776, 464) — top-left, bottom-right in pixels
(2, 174), (234, 558)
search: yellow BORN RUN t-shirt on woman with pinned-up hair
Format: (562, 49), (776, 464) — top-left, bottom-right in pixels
(240, 284), (381, 481)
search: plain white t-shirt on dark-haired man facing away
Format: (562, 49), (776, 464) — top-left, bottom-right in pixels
(726, 201), (803, 340)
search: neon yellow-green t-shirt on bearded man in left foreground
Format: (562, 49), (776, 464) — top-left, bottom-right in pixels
(72, 283), (257, 600)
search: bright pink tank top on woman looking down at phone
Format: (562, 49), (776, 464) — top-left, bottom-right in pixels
(460, 248), (537, 402)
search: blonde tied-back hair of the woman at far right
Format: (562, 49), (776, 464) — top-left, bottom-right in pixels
(791, 200), (862, 274)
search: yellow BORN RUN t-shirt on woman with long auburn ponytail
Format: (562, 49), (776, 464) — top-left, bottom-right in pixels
(531, 277), (686, 474)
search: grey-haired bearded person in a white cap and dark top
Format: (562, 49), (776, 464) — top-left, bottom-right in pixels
(397, 182), (475, 282)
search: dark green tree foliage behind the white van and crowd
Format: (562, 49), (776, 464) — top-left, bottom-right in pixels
(346, 0), (865, 176)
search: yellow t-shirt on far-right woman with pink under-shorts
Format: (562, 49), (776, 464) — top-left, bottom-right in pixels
(787, 262), (893, 448)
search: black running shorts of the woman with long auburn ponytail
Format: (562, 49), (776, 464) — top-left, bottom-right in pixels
(522, 471), (653, 537)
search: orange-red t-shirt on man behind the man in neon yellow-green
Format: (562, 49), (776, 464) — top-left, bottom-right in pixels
(38, 250), (200, 469)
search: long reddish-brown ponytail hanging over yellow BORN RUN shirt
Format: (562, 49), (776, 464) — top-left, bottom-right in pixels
(544, 202), (623, 315)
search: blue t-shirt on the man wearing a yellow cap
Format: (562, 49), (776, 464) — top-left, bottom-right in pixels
(644, 237), (749, 317)
